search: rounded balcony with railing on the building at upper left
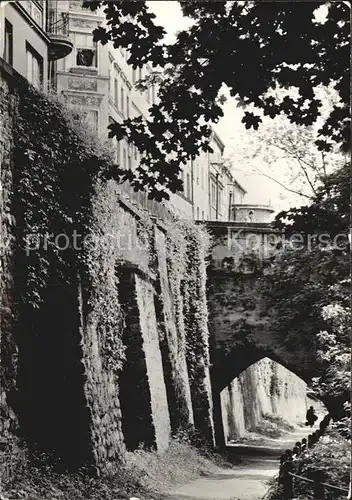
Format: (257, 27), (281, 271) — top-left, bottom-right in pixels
(46, 9), (73, 61)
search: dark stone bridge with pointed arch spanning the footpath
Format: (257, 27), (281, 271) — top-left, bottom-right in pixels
(207, 222), (324, 445)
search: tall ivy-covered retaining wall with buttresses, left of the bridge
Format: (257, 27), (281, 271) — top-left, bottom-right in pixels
(1, 65), (214, 473)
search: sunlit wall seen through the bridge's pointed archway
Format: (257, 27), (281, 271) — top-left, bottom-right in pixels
(221, 358), (307, 441)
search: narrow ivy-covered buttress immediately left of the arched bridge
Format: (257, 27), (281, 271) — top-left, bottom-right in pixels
(167, 225), (215, 444)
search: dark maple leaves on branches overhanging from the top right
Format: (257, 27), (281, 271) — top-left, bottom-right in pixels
(83, 0), (349, 199)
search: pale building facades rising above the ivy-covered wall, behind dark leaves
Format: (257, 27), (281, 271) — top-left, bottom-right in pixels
(0, 0), (250, 221)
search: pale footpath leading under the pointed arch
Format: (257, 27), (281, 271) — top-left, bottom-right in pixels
(164, 427), (317, 500)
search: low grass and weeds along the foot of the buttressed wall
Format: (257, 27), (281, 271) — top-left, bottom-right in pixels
(0, 437), (236, 500)
